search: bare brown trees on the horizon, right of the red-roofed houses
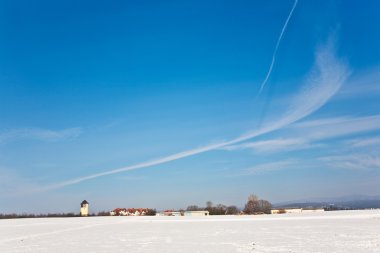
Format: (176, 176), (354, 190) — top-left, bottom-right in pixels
(186, 195), (272, 215)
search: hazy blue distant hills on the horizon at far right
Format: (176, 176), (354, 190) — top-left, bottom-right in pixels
(273, 195), (380, 210)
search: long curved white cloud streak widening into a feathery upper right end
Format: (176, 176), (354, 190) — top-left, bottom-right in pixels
(33, 40), (350, 192)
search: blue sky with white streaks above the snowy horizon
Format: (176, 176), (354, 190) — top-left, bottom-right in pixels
(0, 0), (380, 212)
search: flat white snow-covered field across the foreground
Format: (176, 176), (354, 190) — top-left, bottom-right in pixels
(0, 210), (380, 253)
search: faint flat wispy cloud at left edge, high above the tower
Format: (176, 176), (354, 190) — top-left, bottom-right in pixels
(0, 127), (83, 144)
